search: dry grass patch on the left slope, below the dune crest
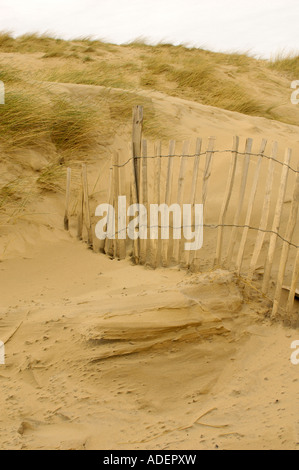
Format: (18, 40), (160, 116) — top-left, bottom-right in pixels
(0, 56), (168, 220)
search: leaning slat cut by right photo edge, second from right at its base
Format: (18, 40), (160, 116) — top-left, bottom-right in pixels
(272, 162), (299, 318)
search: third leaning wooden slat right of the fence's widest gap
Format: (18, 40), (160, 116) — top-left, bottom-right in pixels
(236, 139), (267, 275)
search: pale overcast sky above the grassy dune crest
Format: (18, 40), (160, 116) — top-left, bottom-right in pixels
(0, 0), (299, 57)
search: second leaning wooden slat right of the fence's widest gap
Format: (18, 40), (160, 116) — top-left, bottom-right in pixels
(226, 138), (253, 268)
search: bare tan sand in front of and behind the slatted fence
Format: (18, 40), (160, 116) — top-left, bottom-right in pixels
(0, 79), (299, 449)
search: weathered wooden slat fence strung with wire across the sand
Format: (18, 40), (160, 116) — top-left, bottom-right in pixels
(64, 107), (299, 324)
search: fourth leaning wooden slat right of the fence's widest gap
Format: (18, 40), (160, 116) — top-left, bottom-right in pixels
(247, 142), (278, 281)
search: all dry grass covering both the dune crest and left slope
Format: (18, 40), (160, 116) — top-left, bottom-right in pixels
(0, 32), (299, 224)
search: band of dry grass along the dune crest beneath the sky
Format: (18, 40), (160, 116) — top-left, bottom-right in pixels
(0, 32), (299, 122)
